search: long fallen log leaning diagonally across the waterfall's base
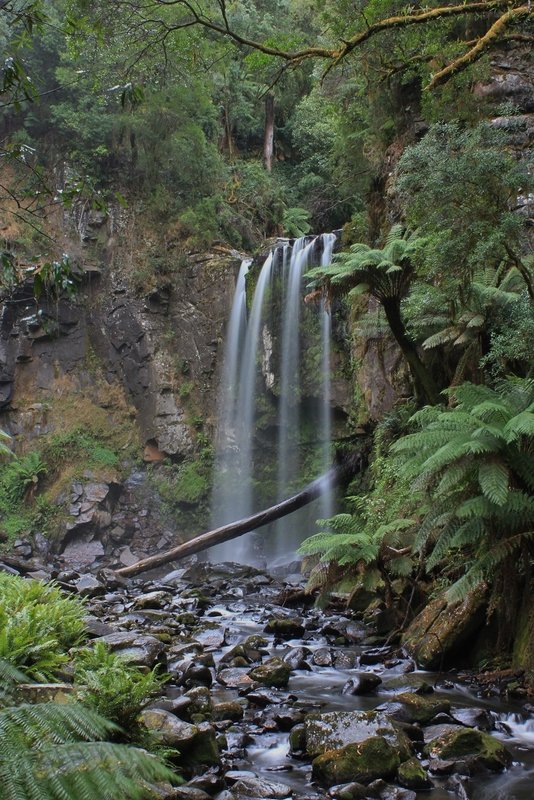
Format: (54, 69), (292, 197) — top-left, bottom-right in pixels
(115, 452), (367, 576)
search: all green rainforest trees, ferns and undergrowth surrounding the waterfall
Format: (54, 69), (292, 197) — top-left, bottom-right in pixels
(0, 0), (534, 799)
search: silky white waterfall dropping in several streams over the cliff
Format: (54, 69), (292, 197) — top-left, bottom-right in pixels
(209, 234), (336, 564)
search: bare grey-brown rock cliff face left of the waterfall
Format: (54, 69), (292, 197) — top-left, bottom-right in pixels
(0, 211), (240, 459)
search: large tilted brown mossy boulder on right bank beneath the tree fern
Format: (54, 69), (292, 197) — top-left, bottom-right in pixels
(402, 585), (487, 669)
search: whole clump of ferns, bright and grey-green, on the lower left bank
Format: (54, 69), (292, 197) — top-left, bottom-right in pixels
(0, 574), (179, 800)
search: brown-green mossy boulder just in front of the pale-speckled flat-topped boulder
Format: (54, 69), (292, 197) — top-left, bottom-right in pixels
(312, 736), (399, 786)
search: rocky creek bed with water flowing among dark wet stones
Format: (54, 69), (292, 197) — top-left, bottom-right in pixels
(5, 562), (534, 800)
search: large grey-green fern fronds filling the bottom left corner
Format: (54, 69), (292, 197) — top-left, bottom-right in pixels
(0, 659), (175, 800)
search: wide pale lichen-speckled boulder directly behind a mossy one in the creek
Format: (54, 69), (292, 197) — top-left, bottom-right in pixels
(304, 711), (412, 760)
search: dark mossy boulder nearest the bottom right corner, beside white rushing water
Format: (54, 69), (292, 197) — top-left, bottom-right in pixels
(424, 728), (512, 772)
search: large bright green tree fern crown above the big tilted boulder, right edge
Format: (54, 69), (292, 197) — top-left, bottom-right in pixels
(392, 380), (534, 600)
